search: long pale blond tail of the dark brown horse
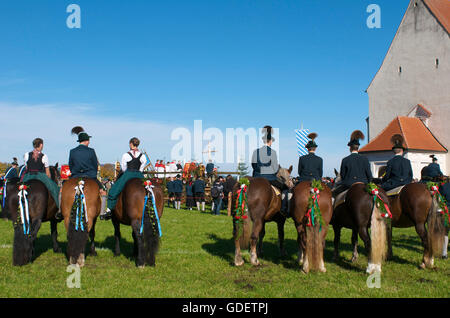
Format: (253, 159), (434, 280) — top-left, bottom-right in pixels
(369, 202), (387, 269)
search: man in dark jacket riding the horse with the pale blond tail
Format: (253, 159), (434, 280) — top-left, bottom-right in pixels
(333, 130), (372, 197)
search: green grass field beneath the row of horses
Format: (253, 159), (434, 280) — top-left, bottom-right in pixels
(0, 208), (450, 298)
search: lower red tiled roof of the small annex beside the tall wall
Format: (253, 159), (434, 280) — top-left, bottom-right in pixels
(359, 116), (447, 153)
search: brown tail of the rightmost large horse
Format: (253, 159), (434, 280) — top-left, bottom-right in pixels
(427, 194), (446, 256)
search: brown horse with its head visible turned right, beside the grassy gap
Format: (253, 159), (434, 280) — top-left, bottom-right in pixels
(232, 166), (293, 266)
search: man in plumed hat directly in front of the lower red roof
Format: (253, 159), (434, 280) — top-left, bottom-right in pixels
(381, 134), (413, 191)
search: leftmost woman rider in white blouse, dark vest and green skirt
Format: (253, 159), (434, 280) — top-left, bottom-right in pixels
(22, 138), (59, 208)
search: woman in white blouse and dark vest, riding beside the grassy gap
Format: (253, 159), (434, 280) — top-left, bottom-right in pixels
(100, 137), (147, 220)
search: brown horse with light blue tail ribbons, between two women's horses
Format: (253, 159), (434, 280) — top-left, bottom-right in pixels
(61, 178), (101, 267)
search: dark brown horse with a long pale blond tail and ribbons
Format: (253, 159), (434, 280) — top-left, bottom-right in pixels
(330, 170), (389, 274)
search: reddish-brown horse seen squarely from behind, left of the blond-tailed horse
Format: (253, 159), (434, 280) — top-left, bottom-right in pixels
(291, 181), (333, 273)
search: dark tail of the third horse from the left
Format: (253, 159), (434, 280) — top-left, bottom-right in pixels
(143, 201), (159, 266)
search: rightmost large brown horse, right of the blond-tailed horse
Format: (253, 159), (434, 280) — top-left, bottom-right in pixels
(388, 183), (445, 268)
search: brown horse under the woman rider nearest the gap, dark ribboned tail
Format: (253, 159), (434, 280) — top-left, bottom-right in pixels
(112, 178), (164, 267)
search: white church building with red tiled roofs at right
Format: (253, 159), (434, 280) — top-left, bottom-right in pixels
(360, 0), (450, 179)
